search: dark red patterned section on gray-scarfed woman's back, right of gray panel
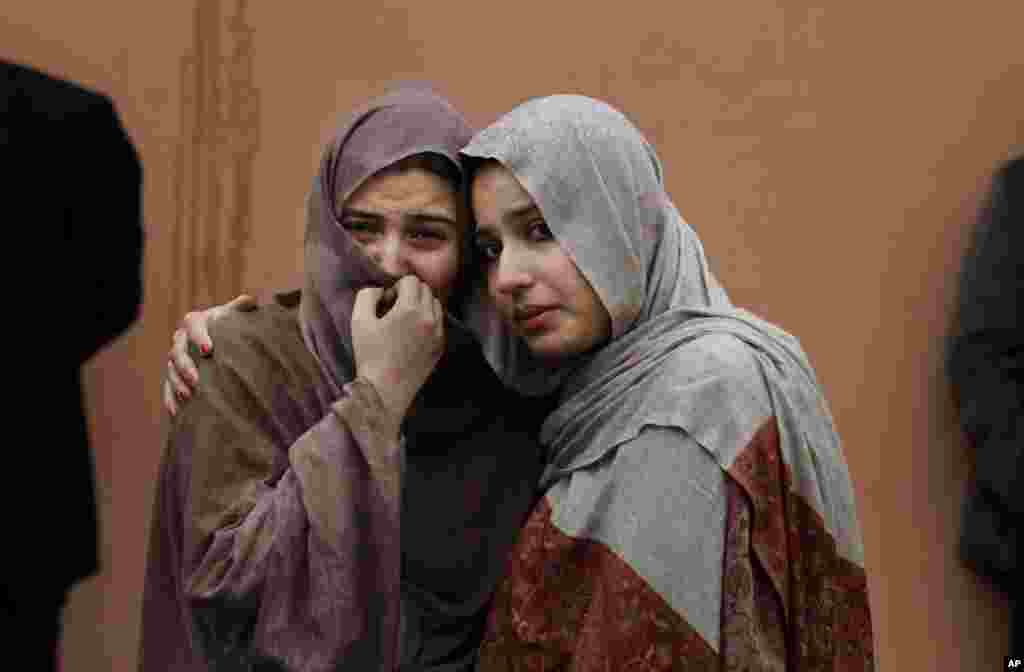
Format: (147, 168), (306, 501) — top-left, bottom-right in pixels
(722, 418), (874, 672)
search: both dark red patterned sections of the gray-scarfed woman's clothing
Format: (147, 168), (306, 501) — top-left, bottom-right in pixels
(479, 420), (874, 672)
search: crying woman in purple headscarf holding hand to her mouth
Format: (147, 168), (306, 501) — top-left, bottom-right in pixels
(139, 88), (543, 672)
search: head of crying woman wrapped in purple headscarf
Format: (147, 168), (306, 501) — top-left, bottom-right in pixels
(299, 85), (472, 395)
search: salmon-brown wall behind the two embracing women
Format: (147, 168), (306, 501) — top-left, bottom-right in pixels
(0, 0), (1024, 672)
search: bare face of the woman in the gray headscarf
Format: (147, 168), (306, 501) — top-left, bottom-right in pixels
(472, 161), (611, 359)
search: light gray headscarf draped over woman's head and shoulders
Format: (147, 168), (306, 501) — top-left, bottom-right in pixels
(462, 90), (863, 566)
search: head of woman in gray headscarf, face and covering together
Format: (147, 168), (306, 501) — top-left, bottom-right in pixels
(463, 95), (668, 362)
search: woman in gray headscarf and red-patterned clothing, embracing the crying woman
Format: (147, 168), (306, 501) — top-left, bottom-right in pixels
(165, 95), (876, 672)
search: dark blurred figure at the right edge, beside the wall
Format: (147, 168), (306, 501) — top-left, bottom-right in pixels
(947, 157), (1024, 656)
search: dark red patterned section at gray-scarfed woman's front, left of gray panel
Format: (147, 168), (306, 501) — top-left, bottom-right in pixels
(479, 499), (720, 672)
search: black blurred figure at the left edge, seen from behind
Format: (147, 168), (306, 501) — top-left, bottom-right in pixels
(0, 61), (142, 670)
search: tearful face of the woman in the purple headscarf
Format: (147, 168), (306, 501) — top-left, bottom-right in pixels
(338, 167), (463, 306)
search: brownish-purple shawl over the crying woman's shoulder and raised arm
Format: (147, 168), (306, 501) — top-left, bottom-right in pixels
(142, 318), (400, 670)
